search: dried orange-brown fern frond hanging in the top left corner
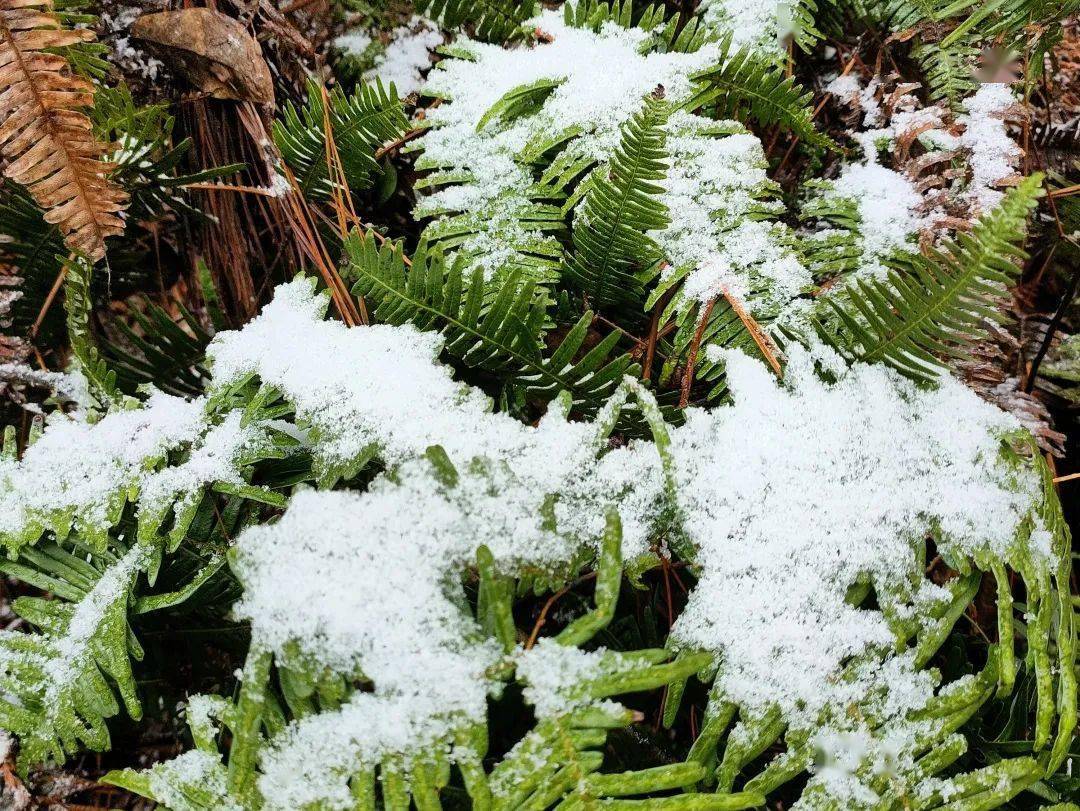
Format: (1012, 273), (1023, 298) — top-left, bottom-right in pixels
(0, 0), (127, 259)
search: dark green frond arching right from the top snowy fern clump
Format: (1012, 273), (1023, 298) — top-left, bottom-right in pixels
(680, 37), (838, 150)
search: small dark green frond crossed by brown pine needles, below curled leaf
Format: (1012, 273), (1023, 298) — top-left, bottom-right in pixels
(273, 79), (408, 198)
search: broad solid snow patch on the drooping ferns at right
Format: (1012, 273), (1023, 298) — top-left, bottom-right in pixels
(672, 350), (1038, 722)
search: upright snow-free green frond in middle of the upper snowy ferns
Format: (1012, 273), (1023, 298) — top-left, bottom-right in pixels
(565, 91), (671, 313)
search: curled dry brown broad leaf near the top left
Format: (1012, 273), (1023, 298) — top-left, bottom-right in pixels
(132, 9), (273, 104)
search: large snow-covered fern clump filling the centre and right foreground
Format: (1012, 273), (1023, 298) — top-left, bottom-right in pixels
(2, 281), (1062, 808)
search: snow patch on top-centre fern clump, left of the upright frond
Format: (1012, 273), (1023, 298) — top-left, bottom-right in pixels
(416, 11), (718, 272)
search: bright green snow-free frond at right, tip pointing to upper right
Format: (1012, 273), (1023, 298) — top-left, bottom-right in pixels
(818, 175), (1042, 380)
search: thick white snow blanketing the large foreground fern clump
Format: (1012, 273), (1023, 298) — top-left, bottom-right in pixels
(212, 280), (1052, 808)
